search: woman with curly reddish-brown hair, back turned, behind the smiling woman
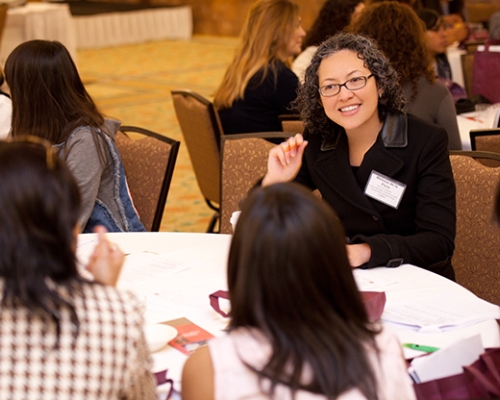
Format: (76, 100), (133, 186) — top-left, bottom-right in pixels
(347, 1), (462, 150)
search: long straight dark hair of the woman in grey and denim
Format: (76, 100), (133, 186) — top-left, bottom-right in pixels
(5, 40), (104, 144)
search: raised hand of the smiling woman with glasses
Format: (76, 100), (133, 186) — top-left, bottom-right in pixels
(262, 133), (307, 186)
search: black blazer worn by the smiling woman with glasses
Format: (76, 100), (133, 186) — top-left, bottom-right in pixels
(296, 113), (456, 279)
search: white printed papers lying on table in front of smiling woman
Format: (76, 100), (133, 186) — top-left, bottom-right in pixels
(382, 293), (500, 332)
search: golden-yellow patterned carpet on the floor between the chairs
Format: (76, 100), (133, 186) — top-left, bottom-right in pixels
(78, 36), (237, 232)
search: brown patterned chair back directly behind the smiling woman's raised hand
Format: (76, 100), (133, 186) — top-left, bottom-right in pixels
(220, 132), (290, 233)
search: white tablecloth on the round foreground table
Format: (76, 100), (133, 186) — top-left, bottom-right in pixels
(78, 232), (500, 396)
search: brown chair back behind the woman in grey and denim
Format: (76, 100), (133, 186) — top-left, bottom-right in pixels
(116, 126), (180, 232)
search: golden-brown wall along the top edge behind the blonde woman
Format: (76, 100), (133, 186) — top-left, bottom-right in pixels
(146, 0), (325, 36)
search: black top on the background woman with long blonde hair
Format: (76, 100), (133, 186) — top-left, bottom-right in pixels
(219, 61), (299, 134)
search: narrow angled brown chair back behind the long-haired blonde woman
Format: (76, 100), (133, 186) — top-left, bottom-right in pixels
(172, 90), (222, 232)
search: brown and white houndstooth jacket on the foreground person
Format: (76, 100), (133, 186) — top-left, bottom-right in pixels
(0, 282), (157, 400)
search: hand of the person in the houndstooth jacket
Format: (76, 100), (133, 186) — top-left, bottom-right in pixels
(85, 226), (125, 286)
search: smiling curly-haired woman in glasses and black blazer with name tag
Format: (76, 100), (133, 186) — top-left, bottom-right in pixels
(262, 32), (456, 280)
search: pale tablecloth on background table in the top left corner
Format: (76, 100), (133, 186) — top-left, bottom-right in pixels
(0, 2), (76, 65)
